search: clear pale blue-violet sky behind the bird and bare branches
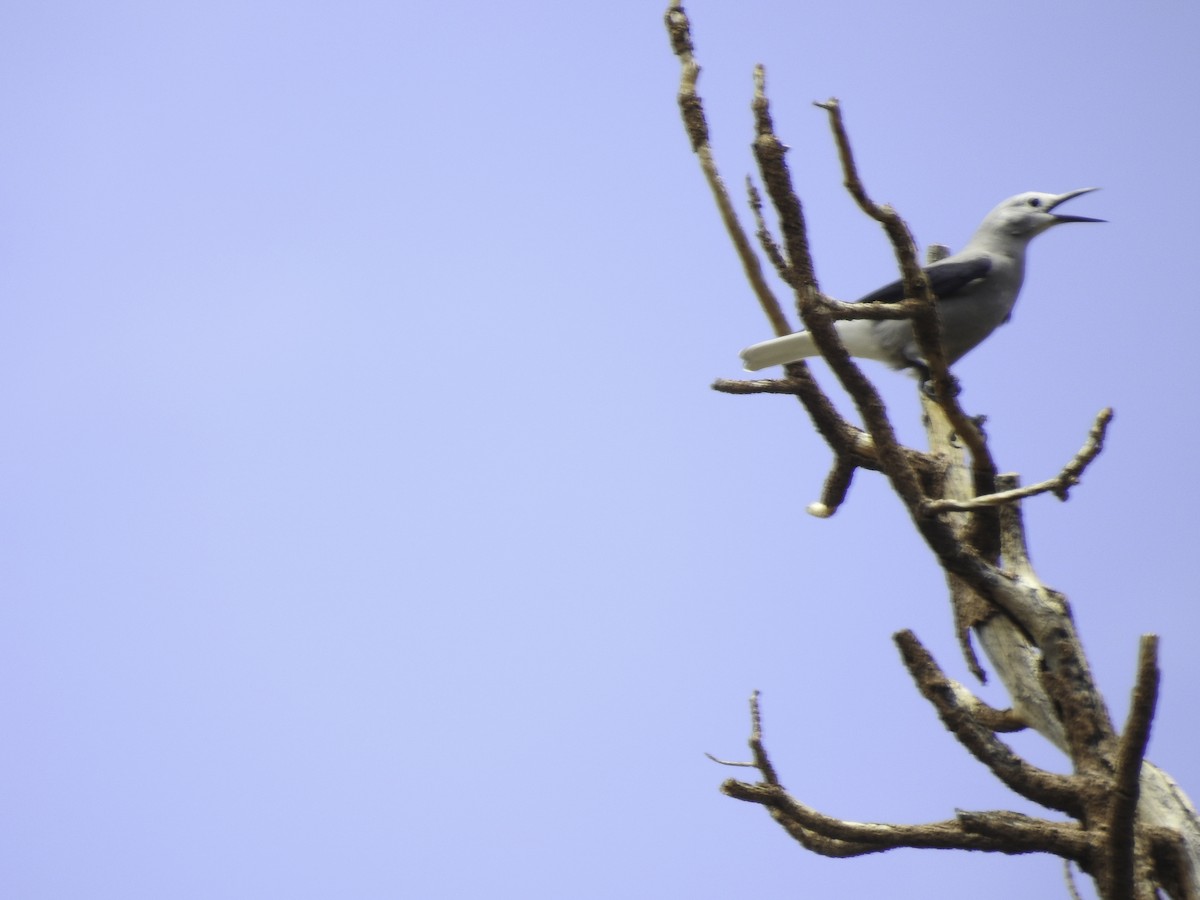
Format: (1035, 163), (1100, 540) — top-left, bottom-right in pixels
(0, 0), (1200, 900)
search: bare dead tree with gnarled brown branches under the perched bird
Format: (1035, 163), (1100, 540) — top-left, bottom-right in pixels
(666, 0), (1200, 900)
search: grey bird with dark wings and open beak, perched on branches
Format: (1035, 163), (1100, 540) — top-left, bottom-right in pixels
(742, 187), (1104, 374)
